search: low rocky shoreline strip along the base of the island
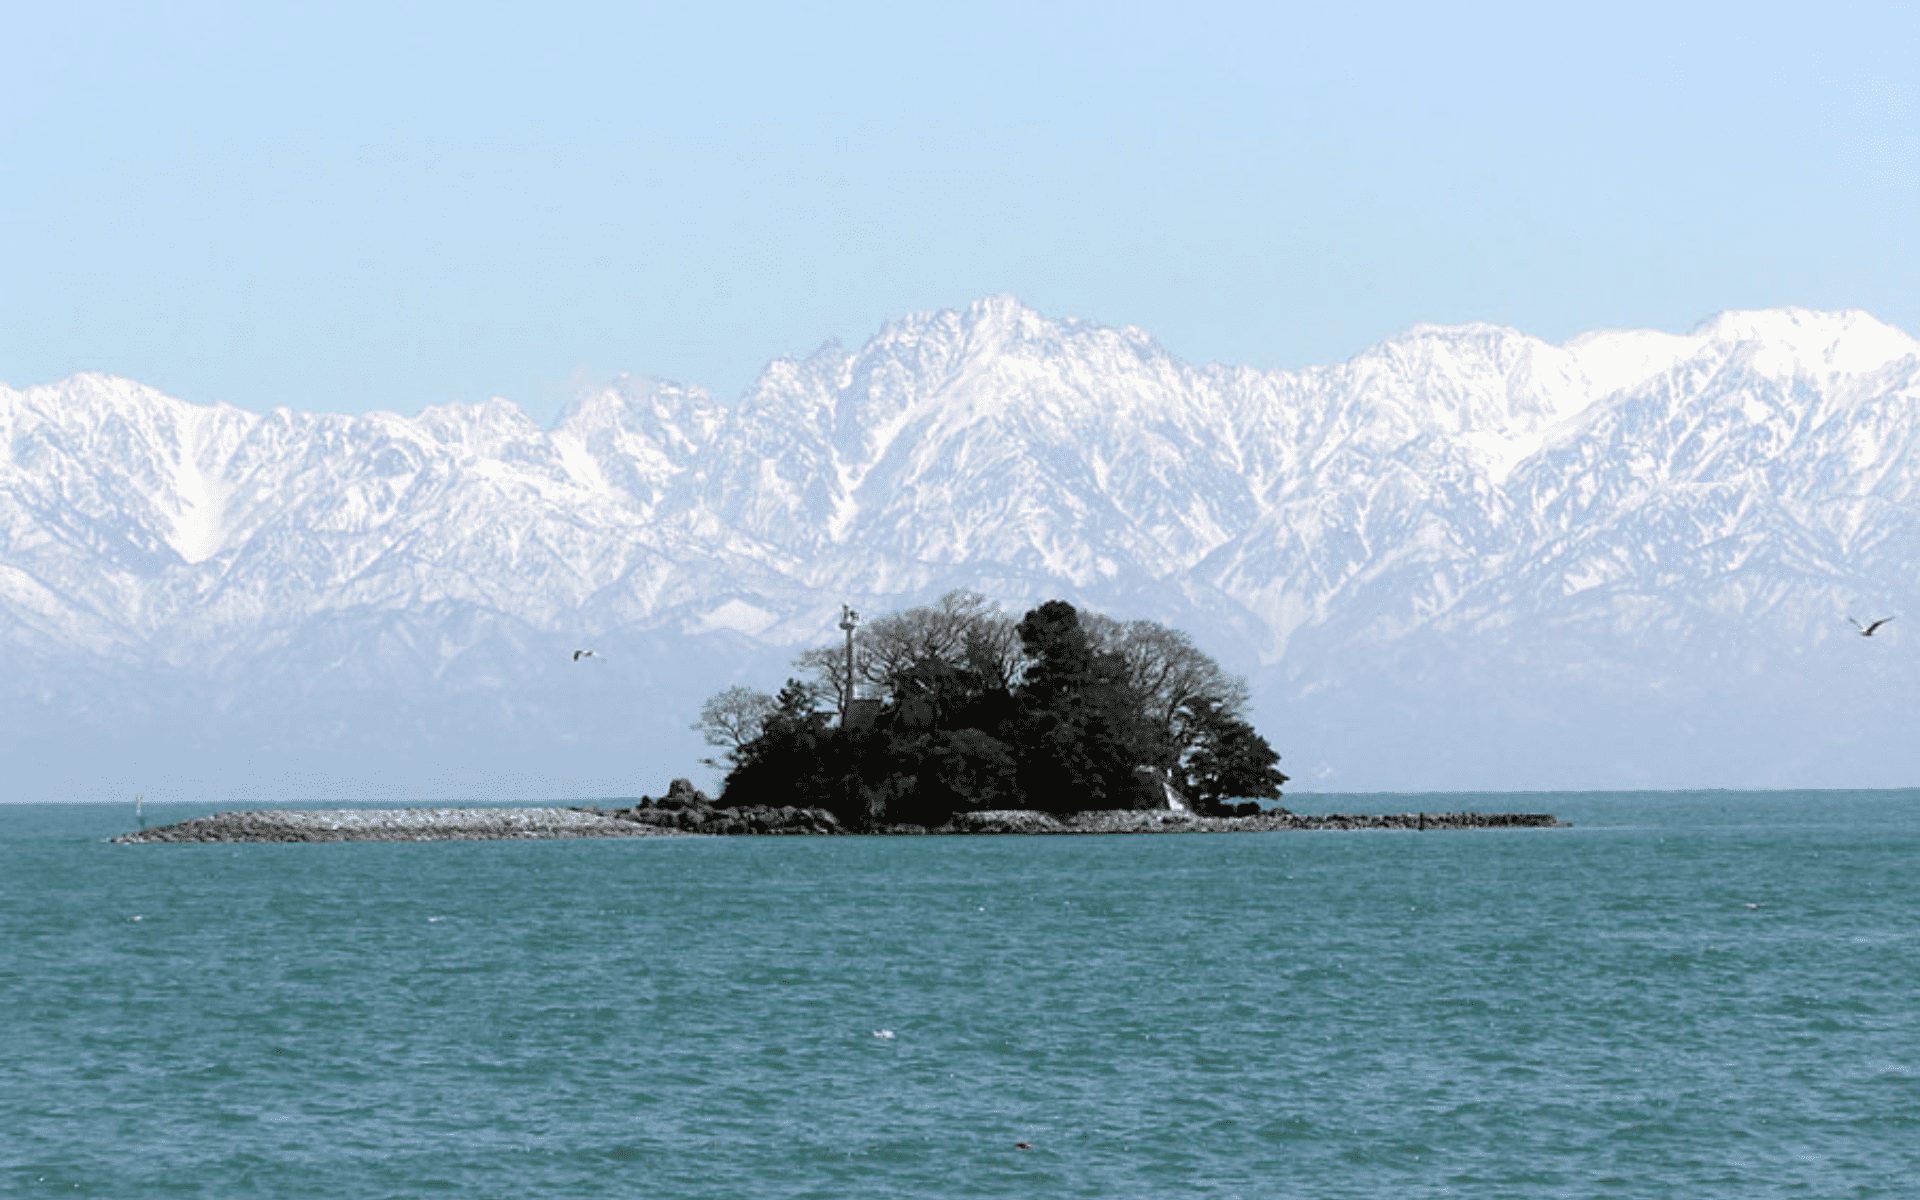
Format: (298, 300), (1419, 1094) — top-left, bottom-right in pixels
(113, 801), (1567, 845)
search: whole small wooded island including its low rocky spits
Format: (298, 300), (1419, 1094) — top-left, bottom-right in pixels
(115, 591), (1561, 843)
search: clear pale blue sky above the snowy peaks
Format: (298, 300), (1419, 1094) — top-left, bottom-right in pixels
(0, 0), (1920, 419)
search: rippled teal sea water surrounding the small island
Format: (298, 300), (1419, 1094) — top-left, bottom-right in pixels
(0, 791), (1920, 1198)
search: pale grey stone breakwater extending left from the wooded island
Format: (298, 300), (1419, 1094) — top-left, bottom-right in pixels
(113, 808), (672, 843)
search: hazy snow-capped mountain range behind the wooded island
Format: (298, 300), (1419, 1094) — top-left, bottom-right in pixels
(0, 298), (1920, 799)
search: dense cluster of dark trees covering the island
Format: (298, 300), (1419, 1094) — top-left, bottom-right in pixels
(695, 591), (1286, 828)
